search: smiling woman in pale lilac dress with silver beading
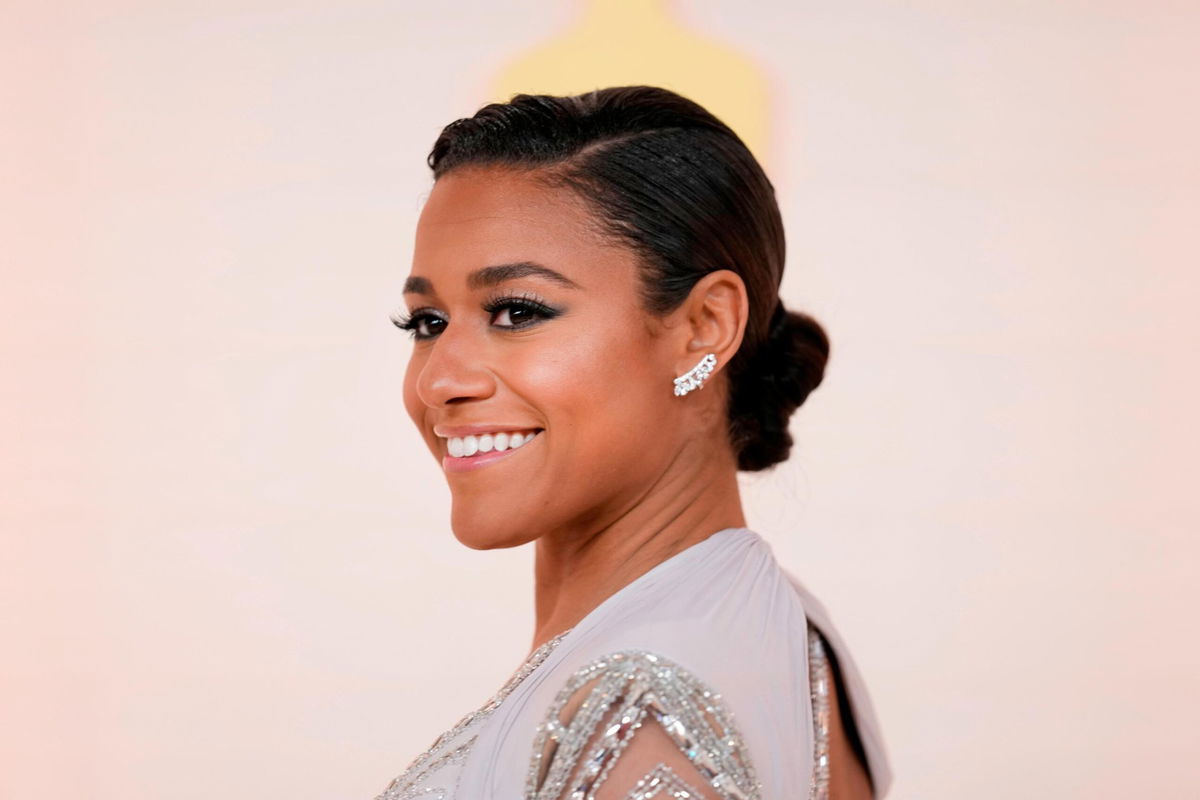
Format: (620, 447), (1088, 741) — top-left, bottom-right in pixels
(380, 86), (890, 800)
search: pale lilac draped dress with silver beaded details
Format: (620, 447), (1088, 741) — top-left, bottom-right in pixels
(376, 528), (892, 800)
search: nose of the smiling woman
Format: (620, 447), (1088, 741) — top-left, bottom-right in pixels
(413, 324), (496, 408)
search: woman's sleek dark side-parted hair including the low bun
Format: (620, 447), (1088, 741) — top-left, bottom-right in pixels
(428, 86), (829, 471)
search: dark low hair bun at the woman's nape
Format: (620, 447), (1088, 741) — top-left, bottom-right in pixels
(730, 301), (829, 471)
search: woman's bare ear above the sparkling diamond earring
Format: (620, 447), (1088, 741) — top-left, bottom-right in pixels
(676, 270), (750, 375)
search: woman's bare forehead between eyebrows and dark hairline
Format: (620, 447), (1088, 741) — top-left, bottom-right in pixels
(412, 167), (636, 290)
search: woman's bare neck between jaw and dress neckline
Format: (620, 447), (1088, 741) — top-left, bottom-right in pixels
(533, 441), (745, 649)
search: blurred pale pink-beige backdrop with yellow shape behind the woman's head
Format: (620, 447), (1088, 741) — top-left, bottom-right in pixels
(0, 0), (1200, 800)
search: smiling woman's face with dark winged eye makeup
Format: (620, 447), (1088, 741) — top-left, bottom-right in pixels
(404, 167), (686, 549)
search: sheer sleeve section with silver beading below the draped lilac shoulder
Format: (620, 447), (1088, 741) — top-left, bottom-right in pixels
(526, 650), (761, 800)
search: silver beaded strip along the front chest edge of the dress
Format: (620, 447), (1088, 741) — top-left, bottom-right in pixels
(376, 631), (570, 800)
